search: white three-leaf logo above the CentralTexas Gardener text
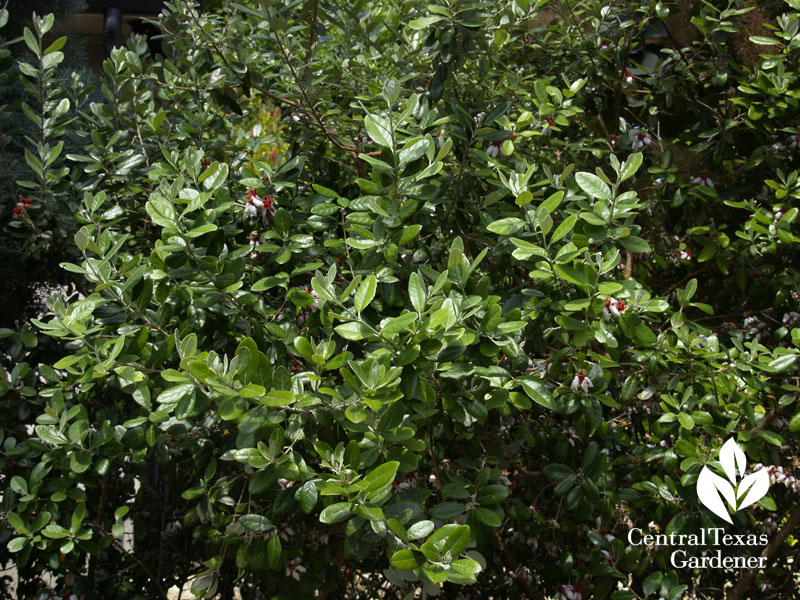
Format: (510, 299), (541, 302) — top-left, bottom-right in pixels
(697, 438), (769, 524)
